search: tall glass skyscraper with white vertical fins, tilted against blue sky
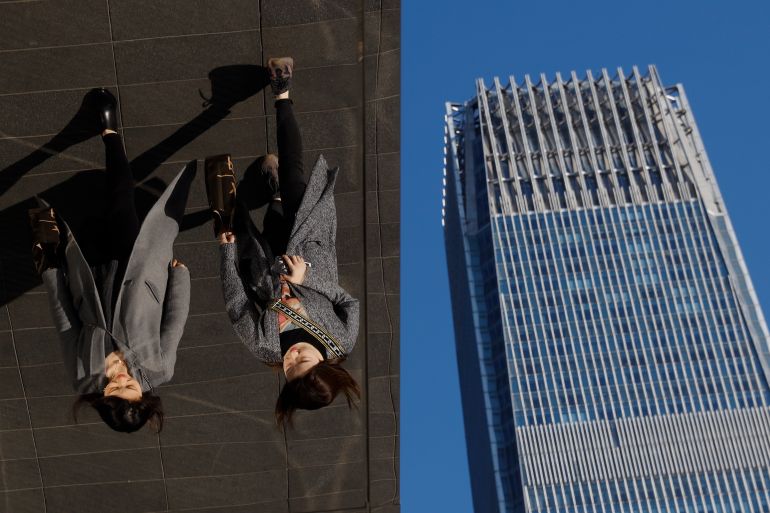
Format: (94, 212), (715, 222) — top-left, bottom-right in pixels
(443, 67), (770, 513)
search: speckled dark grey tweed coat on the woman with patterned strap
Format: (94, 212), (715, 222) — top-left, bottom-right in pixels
(220, 156), (359, 362)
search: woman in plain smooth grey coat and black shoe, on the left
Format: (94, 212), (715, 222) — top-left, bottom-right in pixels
(30, 89), (195, 432)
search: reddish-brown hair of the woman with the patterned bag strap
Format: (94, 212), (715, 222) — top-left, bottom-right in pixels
(275, 358), (361, 426)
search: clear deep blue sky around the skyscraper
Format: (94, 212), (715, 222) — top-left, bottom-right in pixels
(401, 0), (770, 513)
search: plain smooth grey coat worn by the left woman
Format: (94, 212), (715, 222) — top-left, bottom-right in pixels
(42, 164), (194, 393)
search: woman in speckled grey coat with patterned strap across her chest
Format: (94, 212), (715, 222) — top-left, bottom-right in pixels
(216, 58), (360, 424)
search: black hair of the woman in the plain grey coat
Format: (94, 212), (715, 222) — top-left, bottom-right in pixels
(72, 392), (163, 433)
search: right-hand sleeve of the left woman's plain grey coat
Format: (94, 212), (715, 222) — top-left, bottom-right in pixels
(160, 266), (190, 360)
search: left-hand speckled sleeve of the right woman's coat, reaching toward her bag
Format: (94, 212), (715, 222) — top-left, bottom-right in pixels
(220, 243), (274, 361)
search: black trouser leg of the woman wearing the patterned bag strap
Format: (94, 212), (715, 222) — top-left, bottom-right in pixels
(264, 99), (308, 256)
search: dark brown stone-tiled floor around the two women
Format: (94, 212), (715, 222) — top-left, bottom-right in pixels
(0, 0), (400, 513)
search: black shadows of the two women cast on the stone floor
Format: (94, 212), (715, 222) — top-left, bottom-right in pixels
(0, 65), (270, 305)
